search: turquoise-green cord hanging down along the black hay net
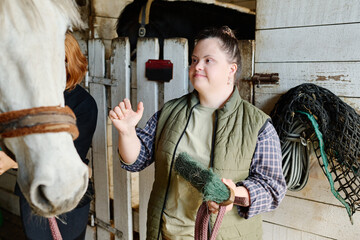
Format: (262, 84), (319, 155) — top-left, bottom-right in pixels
(298, 111), (354, 224)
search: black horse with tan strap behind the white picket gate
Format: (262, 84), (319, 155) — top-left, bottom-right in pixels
(116, 0), (255, 60)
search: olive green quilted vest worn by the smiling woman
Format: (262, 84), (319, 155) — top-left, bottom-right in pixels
(147, 88), (269, 240)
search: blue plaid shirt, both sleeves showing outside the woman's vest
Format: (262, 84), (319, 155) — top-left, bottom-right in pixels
(122, 111), (286, 218)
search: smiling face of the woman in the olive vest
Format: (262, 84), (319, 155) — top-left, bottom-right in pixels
(189, 38), (237, 94)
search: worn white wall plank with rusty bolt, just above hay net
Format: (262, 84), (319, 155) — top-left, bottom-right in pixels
(255, 62), (360, 97)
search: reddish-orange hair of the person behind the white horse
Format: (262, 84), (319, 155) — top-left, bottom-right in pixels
(65, 32), (88, 90)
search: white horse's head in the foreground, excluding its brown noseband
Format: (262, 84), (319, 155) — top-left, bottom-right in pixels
(0, 0), (88, 217)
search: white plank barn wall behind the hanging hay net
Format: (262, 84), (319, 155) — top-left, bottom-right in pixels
(254, 0), (360, 240)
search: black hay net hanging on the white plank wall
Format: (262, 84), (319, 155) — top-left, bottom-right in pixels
(270, 83), (360, 219)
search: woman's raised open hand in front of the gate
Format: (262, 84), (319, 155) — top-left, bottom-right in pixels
(109, 98), (144, 134)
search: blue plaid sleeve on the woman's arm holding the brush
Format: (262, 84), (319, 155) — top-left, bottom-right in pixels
(236, 122), (286, 218)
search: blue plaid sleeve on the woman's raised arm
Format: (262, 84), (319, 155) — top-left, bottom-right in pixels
(121, 111), (160, 172)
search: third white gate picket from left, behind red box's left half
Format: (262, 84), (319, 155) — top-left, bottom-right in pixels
(136, 38), (159, 240)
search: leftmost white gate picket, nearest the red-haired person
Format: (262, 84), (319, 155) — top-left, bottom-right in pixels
(89, 39), (110, 240)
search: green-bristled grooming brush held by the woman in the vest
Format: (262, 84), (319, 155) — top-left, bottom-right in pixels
(174, 152), (235, 205)
